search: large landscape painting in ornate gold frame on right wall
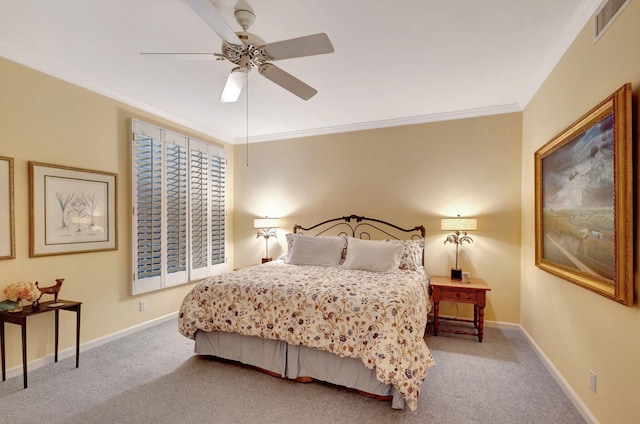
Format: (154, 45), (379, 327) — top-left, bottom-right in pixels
(535, 83), (634, 306)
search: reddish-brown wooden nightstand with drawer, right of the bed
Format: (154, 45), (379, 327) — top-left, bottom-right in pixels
(429, 275), (491, 342)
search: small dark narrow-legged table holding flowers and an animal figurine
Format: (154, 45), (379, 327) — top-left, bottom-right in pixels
(0, 299), (82, 389)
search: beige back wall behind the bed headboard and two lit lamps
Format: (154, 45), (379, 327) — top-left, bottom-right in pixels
(235, 113), (522, 323)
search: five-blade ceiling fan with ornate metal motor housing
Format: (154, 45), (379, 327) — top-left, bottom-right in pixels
(141, 0), (334, 102)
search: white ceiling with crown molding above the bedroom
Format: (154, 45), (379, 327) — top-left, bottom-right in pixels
(0, 0), (600, 143)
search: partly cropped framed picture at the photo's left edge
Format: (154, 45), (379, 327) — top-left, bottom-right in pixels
(0, 156), (16, 259)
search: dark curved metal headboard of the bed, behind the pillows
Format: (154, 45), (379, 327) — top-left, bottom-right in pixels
(293, 215), (425, 240)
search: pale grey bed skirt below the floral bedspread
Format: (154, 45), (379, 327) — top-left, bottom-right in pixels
(195, 331), (404, 409)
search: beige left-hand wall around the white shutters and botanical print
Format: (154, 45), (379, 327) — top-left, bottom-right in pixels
(0, 58), (233, 369)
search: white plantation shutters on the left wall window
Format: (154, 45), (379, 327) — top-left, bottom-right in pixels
(131, 120), (226, 294)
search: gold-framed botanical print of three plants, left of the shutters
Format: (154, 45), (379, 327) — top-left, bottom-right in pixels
(29, 162), (118, 257)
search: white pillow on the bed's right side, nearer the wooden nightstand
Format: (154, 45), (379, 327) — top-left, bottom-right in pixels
(342, 237), (402, 272)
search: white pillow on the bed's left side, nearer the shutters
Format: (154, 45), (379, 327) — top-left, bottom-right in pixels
(287, 234), (346, 266)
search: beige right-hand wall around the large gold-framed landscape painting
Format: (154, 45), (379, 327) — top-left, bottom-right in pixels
(521, 1), (640, 424)
